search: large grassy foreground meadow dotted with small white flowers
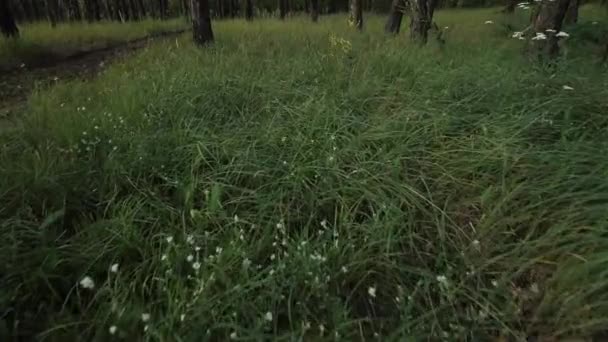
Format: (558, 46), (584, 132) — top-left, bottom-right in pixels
(0, 7), (608, 341)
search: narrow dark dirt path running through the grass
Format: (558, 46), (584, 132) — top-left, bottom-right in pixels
(0, 30), (185, 125)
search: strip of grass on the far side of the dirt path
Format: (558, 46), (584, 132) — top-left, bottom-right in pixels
(0, 19), (186, 66)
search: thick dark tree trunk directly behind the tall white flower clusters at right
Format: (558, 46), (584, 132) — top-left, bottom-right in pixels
(530, 0), (570, 60)
